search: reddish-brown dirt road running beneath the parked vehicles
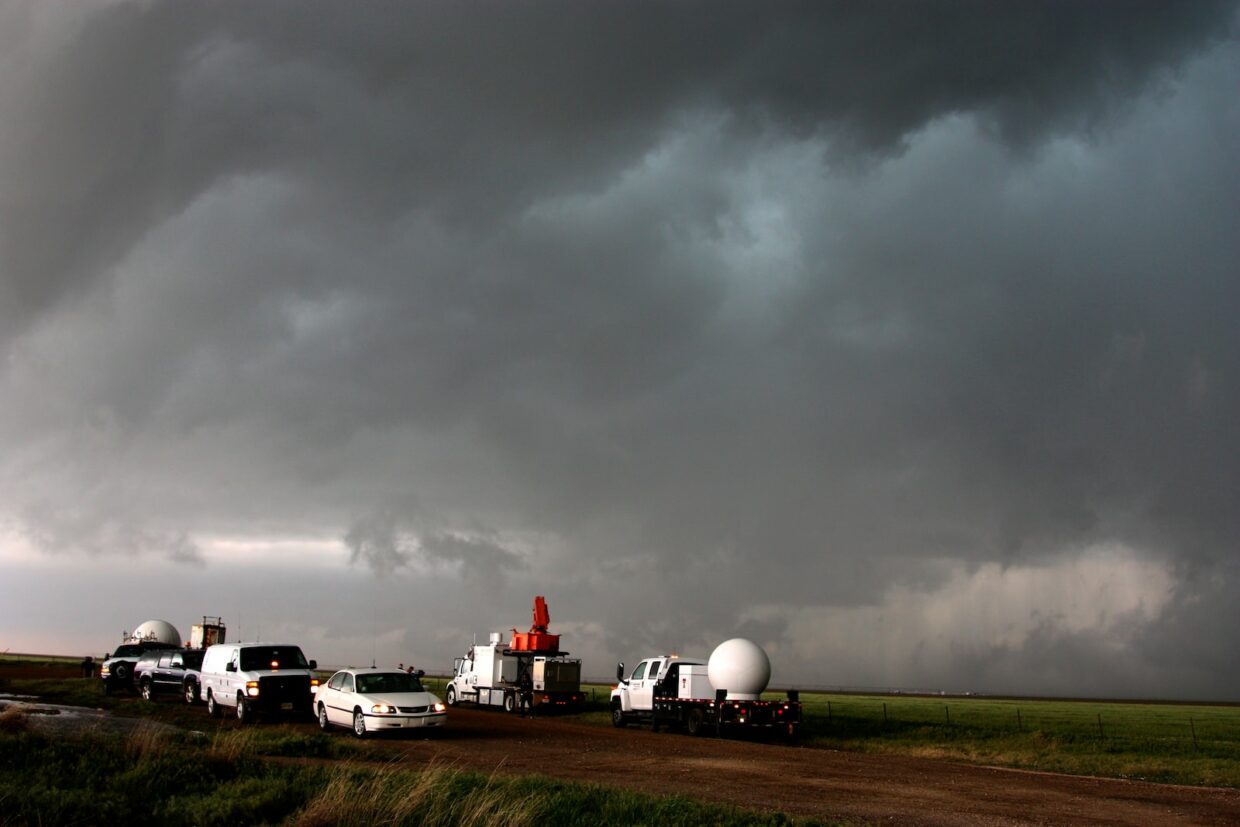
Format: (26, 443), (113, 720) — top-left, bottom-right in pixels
(9, 669), (1240, 827)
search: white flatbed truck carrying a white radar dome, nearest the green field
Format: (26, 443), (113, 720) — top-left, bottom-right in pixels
(611, 637), (801, 740)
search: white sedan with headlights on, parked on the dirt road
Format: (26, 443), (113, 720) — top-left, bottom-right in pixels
(314, 668), (448, 738)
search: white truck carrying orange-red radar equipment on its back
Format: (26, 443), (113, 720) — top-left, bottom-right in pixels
(444, 595), (583, 712)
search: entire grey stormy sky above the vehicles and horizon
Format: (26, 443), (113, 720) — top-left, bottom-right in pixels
(0, 0), (1240, 699)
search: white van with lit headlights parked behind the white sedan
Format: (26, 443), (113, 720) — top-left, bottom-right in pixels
(198, 643), (319, 723)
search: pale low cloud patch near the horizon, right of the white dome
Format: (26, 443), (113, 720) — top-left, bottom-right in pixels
(744, 544), (1180, 694)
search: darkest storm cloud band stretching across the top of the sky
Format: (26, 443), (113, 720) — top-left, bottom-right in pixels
(0, 1), (1233, 337)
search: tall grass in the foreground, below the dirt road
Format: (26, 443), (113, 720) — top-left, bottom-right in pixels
(0, 729), (838, 827)
